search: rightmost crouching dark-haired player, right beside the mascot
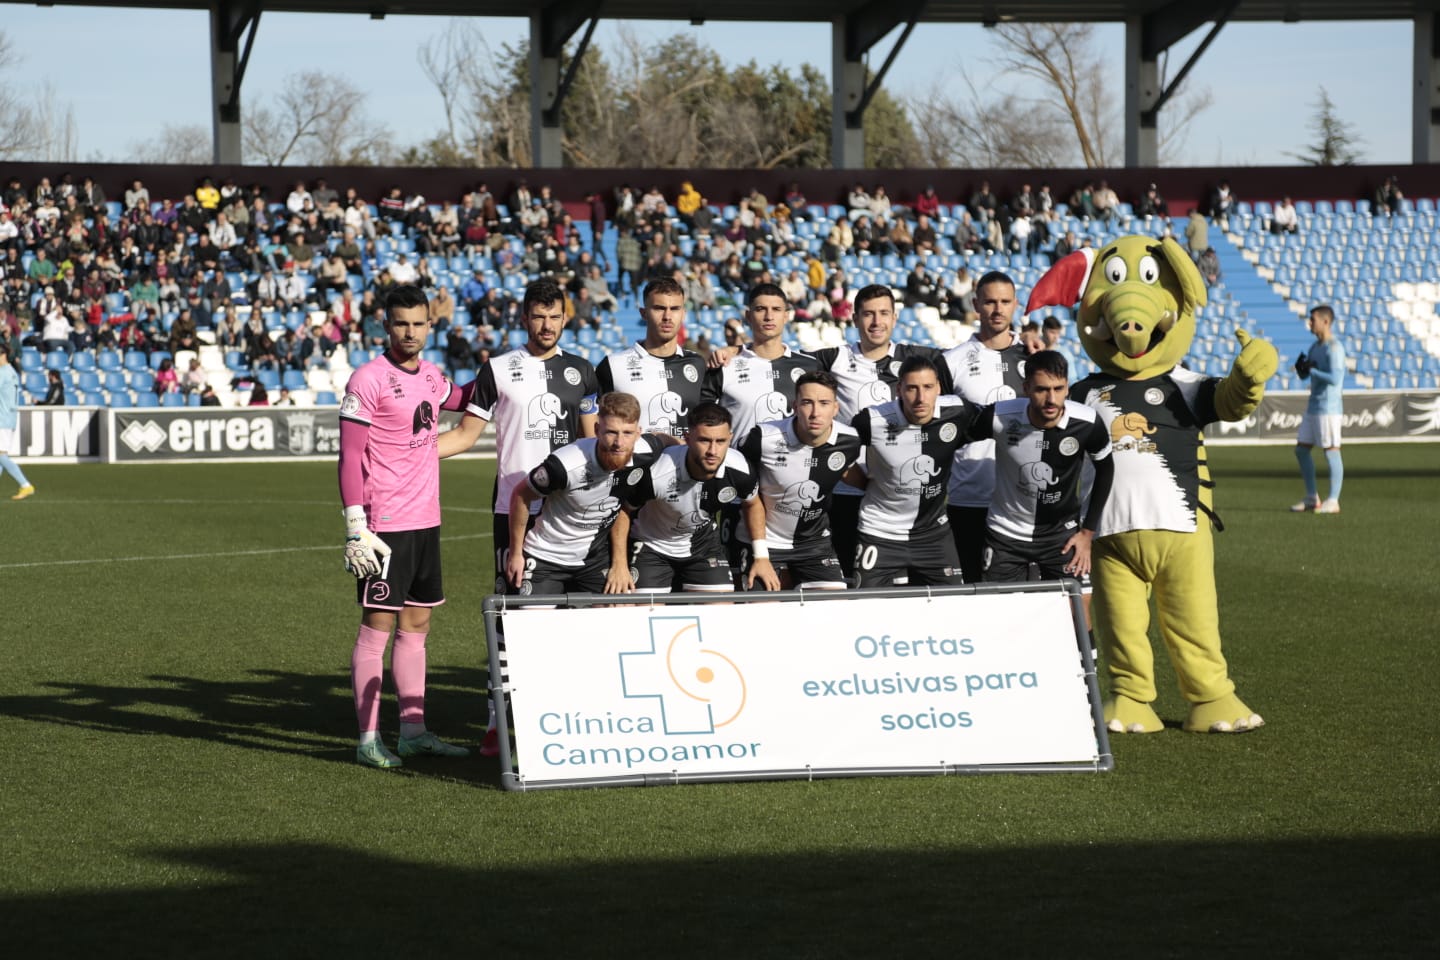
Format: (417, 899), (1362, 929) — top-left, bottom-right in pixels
(965, 350), (1115, 583)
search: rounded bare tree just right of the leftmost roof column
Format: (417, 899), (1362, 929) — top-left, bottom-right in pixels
(243, 71), (389, 167)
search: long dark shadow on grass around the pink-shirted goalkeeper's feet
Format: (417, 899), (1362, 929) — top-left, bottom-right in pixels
(0, 668), (500, 789)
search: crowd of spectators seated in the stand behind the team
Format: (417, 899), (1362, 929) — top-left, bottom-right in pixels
(0, 166), (1400, 396)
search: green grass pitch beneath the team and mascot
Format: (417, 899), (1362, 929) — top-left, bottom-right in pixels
(0, 445), (1440, 960)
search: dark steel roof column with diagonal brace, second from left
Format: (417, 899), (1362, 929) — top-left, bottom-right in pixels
(530, 0), (603, 167)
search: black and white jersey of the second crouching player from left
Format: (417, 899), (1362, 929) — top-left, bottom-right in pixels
(619, 446), (755, 560)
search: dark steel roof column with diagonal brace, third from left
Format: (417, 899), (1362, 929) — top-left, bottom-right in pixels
(829, 0), (927, 170)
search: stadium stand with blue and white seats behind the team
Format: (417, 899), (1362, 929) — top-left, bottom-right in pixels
(0, 174), (1440, 406)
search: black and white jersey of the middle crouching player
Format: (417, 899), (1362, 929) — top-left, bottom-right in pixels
(739, 416), (860, 550)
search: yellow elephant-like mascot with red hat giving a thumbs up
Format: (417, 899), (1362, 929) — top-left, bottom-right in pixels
(1027, 236), (1279, 733)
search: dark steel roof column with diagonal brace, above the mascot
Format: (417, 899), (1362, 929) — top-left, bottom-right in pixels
(1125, 0), (1240, 167)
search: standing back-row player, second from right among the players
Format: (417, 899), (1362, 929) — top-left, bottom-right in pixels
(815, 284), (953, 576)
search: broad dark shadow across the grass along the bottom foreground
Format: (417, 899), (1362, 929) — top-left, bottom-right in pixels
(0, 838), (1440, 960)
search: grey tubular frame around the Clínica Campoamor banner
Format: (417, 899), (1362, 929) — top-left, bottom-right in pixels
(482, 580), (1115, 792)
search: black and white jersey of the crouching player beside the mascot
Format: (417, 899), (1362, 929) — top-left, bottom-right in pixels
(966, 397), (1115, 543)
